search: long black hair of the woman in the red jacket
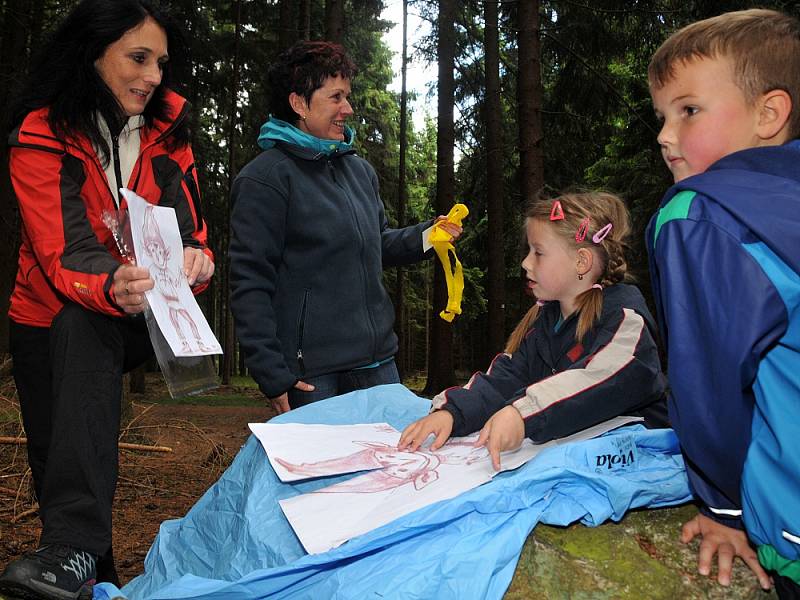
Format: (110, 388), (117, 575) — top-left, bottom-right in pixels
(10, 0), (189, 162)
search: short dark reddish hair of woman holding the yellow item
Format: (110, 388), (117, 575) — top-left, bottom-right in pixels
(267, 40), (358, 124)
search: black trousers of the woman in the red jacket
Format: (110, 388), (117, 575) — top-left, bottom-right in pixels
(10, 304), (153, 556)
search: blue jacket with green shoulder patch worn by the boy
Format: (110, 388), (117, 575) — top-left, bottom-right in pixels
(647, 141), (800, 574)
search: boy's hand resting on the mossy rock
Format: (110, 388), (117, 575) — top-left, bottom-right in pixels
(681, 514), (772, 590)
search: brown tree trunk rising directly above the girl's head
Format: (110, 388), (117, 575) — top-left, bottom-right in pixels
(517, 0), (544, 203)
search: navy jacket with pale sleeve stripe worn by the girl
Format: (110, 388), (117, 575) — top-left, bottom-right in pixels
(434, 284), (666, 443)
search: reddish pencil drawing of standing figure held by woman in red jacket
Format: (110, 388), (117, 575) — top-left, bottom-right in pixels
(142, 206), (211, 352)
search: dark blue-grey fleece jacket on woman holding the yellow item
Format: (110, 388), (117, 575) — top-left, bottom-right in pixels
(230, 142), (431, 397)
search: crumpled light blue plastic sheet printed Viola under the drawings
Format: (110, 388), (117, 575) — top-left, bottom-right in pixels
(94, 385), (690, 600)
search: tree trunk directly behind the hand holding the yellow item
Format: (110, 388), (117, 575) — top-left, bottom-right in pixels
(425, 0), (456, 394)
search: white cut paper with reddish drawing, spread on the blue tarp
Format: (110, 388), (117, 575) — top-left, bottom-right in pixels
(250, 417), (641, 554)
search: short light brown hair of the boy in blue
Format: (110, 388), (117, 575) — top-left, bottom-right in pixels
(647, 8), (800, 138)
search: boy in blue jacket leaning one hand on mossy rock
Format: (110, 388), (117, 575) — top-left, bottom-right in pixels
(647, 10), (800, 598)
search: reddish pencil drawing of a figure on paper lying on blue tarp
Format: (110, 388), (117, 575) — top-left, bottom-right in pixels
(275, 441), (487, 494)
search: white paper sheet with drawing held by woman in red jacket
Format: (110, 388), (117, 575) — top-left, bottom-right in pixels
(121, 189), (222, 356)
